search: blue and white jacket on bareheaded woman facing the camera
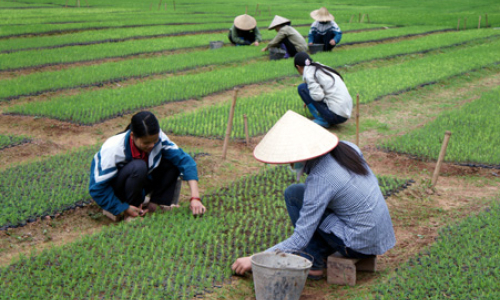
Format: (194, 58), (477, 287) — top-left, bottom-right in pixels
(89, 130), (198, 215)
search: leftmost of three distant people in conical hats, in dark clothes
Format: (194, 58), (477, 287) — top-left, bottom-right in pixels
(229, 14), (262, 46)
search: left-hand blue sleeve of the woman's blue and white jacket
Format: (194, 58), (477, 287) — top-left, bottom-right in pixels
(89, 157), (129, 216)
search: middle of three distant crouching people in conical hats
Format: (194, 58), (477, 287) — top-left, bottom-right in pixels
(262, 16), (307, 58)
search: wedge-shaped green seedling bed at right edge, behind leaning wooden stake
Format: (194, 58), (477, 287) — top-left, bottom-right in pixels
(379, 87), (500, 168)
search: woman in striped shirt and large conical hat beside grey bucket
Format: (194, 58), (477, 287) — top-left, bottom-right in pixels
(232, 111), (396, 279)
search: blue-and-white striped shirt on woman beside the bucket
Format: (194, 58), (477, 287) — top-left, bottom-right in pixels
(268, 142), (396, 255)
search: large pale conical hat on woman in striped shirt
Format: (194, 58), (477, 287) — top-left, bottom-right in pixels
(253, 110), (339, 164)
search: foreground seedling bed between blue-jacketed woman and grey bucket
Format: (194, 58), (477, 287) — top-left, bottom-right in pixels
(0, 167), (406, 299)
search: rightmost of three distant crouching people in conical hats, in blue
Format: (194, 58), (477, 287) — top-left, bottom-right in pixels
(308, 7), (342, 51)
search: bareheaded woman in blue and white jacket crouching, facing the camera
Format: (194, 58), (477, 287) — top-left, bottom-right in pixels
(89, 111), (205, 219)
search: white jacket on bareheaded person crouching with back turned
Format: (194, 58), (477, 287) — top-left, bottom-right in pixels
(303, 66), (352, 119)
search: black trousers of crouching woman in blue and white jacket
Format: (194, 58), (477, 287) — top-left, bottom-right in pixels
(111, 158), (180, 207)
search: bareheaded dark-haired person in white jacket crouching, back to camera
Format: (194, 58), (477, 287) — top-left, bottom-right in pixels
(294, 52), (352, 128)
